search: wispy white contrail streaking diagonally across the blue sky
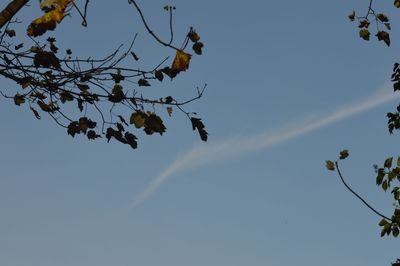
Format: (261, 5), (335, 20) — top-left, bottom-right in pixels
(129, 86), (398, 209)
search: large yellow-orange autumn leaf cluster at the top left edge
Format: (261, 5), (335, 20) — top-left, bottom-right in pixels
(27, 0), (73, 37)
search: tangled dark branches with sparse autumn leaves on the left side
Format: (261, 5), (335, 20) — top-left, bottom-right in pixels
(0, 0), (208, 149)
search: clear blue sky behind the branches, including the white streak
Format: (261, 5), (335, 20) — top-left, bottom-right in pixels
(0, 0), (400, 266)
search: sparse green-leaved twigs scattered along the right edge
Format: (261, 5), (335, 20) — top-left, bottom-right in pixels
(325, 0), (400, 266)
